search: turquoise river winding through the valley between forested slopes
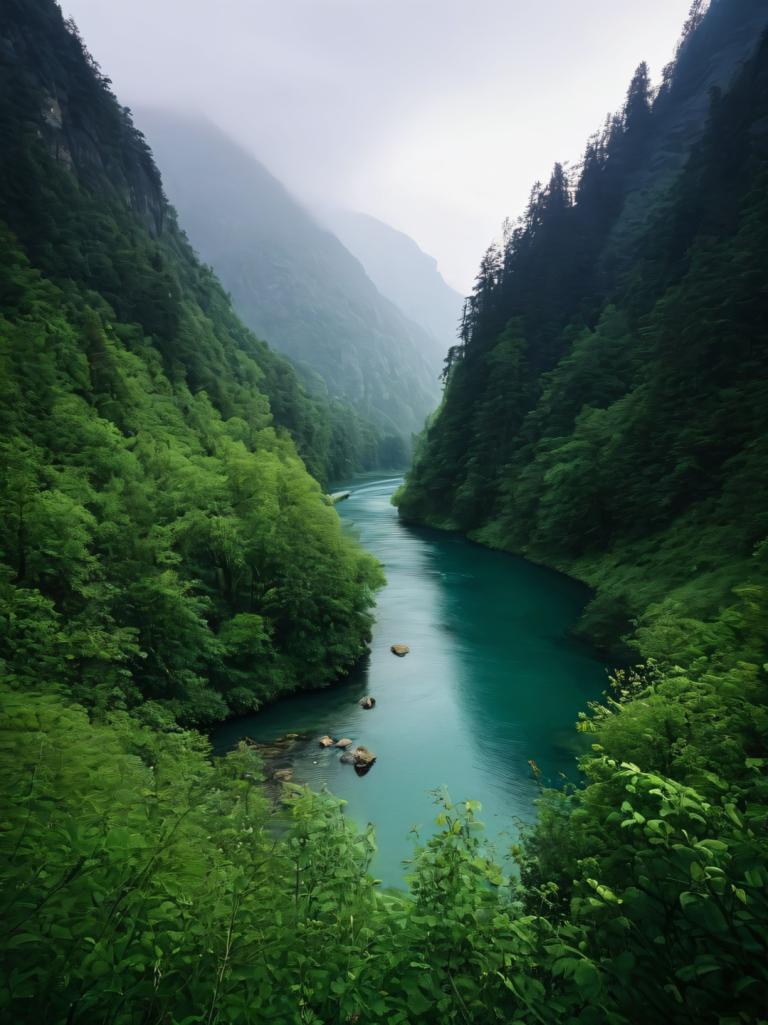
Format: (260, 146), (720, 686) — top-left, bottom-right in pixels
(213, 478), (605, 885)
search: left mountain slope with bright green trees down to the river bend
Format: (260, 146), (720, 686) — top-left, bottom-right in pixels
(0, 0), (377, 723)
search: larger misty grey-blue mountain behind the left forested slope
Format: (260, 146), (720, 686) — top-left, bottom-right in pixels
(136, 110), (439, 438)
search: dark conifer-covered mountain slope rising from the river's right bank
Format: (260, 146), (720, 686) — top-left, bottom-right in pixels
(400, 2), (768, 655)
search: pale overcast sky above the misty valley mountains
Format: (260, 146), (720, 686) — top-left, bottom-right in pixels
(62, 0), (690, 292)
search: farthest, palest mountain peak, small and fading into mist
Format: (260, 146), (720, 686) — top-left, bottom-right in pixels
(323, 210), (463, 363)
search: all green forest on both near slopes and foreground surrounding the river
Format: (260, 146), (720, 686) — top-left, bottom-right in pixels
(0, 0), (768, 1025)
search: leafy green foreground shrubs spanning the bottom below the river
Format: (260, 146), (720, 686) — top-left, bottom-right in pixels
(0, 670), (768, 1025)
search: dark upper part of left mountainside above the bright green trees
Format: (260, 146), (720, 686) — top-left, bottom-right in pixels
(0, 0), (391, 483)
